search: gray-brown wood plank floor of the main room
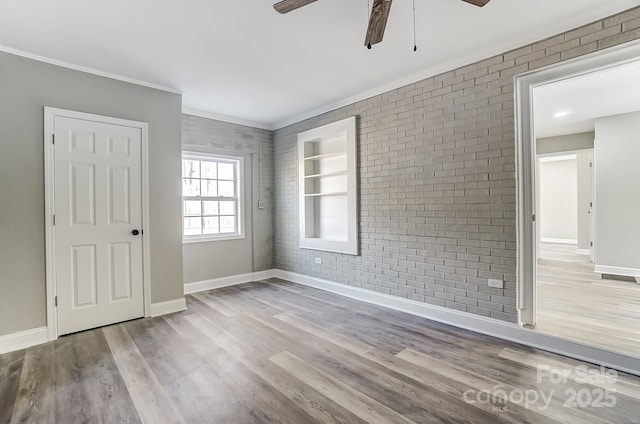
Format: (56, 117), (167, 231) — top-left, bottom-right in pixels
(0, 279), (640, 424)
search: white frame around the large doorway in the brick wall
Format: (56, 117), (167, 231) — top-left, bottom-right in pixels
(514, 40), (640, 326)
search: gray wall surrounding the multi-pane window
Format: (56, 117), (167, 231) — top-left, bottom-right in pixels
(182, 115), (273, 284)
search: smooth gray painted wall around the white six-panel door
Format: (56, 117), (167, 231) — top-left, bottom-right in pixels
(0, 52), (183, 335)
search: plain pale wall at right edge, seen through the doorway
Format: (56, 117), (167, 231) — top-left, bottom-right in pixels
(594, 112), (640, 277)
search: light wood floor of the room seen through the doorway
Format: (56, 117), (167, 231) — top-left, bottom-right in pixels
(536, 243), (640, 357)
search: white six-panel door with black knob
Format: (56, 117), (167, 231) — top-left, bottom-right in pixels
(53, 116), (144, 334)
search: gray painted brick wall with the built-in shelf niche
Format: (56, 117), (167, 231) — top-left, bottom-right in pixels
(275, 8), (640, 322)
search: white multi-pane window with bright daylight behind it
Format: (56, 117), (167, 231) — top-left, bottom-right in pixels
(182, 152), (244, 243)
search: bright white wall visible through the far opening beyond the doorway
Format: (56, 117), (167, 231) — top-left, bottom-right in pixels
(538, 154), (578, 244)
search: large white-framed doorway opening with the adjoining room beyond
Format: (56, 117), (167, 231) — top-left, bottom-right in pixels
(516, 39), (640, 358)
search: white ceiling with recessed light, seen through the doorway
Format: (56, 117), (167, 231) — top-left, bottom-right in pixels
(533, 60), (640, 137)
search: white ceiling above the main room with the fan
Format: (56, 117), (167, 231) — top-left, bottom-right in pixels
(0, 0), (640, 128)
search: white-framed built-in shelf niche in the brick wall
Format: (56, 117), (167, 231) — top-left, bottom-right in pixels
(298, 117), (358, 255)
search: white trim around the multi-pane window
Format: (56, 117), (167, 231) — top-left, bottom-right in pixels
(185, 150), (245, 244)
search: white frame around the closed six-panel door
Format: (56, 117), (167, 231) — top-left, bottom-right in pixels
(43, 106), (151, 340)
